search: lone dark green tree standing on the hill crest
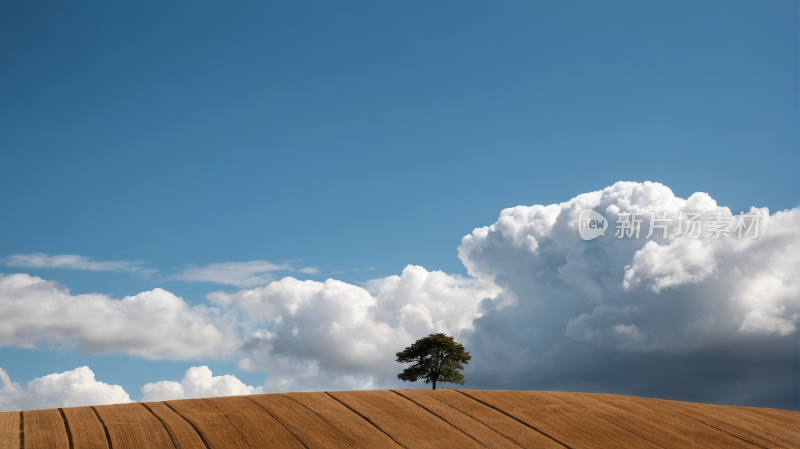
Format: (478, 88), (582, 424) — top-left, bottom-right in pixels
(397, 334), (472, 390)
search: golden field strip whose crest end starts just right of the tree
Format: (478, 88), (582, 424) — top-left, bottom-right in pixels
(459, 390), (658, 449)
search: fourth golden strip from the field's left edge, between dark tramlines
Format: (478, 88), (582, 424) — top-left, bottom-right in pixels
(94, 403), (174, 449)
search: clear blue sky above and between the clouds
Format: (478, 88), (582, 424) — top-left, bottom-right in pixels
(0, 1), (800, 406)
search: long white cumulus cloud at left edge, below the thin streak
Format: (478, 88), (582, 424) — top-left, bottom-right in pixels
(0, 274), (240, 360)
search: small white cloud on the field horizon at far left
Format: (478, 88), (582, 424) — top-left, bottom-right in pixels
(0, 366), (133, 411)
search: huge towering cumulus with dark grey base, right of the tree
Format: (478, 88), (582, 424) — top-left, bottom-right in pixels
(459, 182), (800, 407)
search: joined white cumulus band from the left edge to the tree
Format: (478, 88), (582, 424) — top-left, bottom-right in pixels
(0, 266), (499, 392)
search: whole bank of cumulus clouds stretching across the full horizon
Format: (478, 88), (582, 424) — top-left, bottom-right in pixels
(0, 182), (800, 409)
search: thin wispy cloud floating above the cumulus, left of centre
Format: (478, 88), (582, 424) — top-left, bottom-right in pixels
(172, 260), (294, 287)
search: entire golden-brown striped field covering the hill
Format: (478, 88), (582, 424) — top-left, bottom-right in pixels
(0, 390), (800, 449)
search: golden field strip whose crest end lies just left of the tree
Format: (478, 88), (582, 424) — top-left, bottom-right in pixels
(329, 390), (482, 449)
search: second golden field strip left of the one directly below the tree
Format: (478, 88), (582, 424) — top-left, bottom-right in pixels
(282, 393), (400, 449)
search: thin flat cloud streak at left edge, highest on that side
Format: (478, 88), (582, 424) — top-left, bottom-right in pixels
(0, 253), (158, 276)
